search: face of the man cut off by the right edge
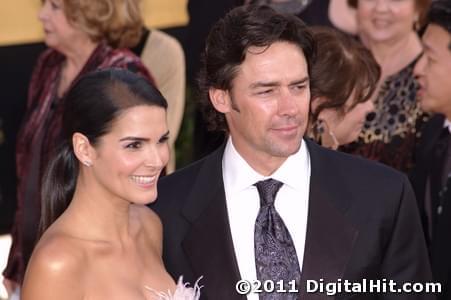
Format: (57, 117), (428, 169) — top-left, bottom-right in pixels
(414, 24), (451, 117)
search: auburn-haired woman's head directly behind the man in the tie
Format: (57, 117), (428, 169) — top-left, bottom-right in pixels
(310, 27), (380, 149)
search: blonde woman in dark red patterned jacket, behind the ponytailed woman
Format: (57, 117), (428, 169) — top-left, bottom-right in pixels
(3, 0), (151, 293)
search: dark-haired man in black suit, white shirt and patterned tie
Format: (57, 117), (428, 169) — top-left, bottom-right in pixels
(154, 7), (432, 300)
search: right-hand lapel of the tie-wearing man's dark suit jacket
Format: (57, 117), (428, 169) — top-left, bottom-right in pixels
(300, 141), (358, 300)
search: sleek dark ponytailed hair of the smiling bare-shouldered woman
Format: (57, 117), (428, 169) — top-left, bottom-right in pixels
(40, 69), (167, 234)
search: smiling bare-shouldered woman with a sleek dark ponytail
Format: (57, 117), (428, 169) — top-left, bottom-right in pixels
(21, 69), (200, 300)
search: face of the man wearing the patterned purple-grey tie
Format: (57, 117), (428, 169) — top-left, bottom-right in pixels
(210, 42), (310, 175)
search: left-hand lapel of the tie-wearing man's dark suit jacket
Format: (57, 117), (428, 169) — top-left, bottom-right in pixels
(182, 147), (245, 300)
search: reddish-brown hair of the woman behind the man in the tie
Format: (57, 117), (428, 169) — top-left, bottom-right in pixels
(310, 27), (381, 123)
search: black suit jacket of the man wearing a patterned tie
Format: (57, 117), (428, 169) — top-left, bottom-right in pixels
(153, 141), (433, 300)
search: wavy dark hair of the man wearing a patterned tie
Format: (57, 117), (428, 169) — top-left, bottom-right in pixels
(199, 5), (315, 131)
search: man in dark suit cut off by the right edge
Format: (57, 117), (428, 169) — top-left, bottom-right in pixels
(411, 0), (451, 299)
